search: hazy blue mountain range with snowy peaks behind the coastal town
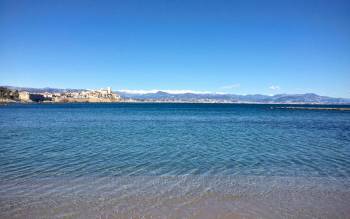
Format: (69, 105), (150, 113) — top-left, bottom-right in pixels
(4, 86), (350, 104)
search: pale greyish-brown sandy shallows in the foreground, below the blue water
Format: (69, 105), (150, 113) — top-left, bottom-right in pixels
(0, 176), (350, 218)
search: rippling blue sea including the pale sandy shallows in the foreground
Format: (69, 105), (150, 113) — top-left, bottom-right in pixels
(0, 103), (350, 218)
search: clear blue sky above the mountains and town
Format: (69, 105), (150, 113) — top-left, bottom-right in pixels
(0, 0), (350, 97)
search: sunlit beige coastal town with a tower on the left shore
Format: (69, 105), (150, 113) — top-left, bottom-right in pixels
(0, 87), (122, 103)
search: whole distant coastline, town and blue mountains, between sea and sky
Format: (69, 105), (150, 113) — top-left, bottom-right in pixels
(0, 86), (350, 105)
